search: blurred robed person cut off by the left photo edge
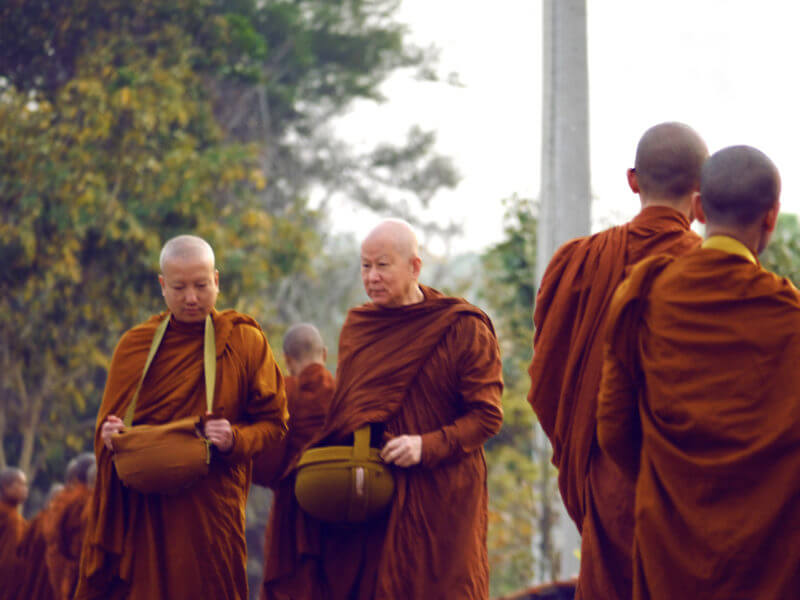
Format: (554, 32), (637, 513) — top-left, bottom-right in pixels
(0, 467), (28, 600)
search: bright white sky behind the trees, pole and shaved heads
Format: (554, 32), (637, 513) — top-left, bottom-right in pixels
(324, 0), (800, 251)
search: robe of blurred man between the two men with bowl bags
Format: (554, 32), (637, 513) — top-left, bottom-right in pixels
(253, 364), (334, 600)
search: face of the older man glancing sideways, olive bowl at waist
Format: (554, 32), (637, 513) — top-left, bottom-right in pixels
(361, 238), (421, 308)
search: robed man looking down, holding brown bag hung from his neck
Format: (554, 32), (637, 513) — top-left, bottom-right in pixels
(75, 236), (288, 600)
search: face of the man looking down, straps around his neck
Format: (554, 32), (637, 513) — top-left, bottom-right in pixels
(158, 257), (219, 323)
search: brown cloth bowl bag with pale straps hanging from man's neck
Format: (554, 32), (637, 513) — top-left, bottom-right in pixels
(111, 314), (217, 494)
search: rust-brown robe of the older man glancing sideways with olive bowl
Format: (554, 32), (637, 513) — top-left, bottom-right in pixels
(294, 286), (503, 600)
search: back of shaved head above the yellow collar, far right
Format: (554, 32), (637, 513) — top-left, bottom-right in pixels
(700, 146), (781, 227)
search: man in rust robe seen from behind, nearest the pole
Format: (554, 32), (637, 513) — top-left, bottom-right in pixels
(528, 123), (708, 600)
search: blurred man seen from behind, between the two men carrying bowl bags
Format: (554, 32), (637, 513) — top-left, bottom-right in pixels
(253, 323), (334, 600)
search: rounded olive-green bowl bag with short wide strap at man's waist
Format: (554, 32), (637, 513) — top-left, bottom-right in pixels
(294, 425), (394, 523)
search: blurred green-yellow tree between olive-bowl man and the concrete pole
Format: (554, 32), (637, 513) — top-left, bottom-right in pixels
(481, 196), (558, 595)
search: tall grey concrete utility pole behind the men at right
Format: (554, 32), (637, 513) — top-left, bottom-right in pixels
(534, 0), (591, 577)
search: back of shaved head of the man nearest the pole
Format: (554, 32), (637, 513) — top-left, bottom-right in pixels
(634, 122), (708, 200)
